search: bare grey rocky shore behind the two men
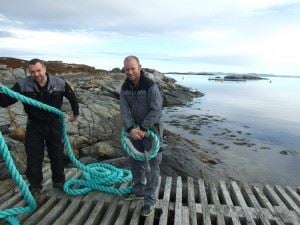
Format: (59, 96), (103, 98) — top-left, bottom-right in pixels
(0, 58), (227, 184)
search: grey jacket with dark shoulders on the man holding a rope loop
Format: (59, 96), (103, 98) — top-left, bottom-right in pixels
(120, 71), (163, 136)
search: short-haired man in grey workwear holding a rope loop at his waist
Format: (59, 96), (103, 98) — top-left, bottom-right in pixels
(120, 56), (162, 216)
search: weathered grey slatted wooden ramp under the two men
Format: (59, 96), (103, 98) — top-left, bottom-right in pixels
(0, 168), (300, 225)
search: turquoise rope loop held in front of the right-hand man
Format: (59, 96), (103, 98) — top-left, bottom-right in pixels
(121, 128), (160, 161)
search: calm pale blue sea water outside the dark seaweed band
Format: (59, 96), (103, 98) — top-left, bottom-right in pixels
(164, 74), (300, 185)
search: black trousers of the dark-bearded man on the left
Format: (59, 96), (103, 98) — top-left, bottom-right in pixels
(25, 119), (65, 189)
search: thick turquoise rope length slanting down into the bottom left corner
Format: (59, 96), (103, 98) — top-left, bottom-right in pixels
(0, 132), (37, 225)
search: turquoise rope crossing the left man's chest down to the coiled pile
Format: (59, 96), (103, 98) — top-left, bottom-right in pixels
(1, 86), (132, 200)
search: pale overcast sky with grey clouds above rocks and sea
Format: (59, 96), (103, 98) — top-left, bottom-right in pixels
(0, 0), (300, 75)
